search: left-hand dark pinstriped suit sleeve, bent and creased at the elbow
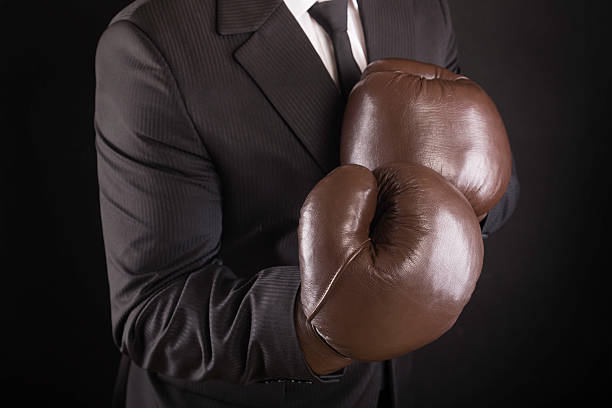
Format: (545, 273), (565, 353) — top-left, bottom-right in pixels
(94, 20), (339, 384)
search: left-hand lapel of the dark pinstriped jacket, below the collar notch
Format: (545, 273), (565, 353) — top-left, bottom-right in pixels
(234, 2), (344, 174)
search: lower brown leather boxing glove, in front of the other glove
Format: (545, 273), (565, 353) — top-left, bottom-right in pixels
(295, 163), (483, 374)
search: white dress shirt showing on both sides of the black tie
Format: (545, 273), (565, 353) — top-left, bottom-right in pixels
(284, 0), (367, 85)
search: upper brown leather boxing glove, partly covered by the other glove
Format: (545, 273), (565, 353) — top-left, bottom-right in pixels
(340, 58), (512, 219)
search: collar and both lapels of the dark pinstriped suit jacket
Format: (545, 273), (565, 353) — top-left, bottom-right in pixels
(217, 0), (412, 174)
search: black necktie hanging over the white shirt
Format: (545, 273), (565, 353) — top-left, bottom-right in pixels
(308, 0), (361, 98)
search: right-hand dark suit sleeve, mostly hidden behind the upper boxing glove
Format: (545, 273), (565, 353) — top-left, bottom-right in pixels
(440, 0), (520, 238)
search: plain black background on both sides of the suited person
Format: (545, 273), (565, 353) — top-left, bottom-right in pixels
(0, 0), (611, 407)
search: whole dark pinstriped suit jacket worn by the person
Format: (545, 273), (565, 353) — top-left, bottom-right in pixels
(95, 0), (518, 407)
